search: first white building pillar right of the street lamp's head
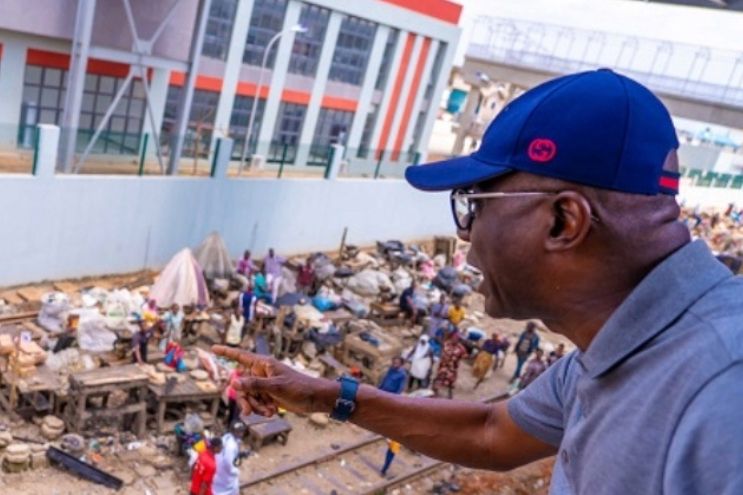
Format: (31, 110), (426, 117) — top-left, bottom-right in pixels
(294, 11), (343, 166)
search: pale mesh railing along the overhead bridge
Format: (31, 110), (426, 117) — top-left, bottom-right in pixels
(467, 17), (743, 107)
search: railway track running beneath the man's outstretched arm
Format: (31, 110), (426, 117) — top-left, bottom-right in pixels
(240, 394), (508, 495)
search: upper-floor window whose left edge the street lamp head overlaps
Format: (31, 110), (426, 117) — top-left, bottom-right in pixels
(289, 4), (330, 77)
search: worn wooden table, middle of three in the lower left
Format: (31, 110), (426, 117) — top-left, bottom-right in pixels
(65, 364), (149, 438)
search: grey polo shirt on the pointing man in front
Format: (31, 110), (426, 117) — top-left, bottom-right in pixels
(508, 241), (743, 495)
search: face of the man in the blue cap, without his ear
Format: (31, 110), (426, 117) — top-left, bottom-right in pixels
(458, 173), (549, 318)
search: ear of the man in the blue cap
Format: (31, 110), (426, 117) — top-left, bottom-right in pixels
(545, 191), (591, 251)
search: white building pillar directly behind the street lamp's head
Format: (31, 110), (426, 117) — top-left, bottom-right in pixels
(256, 0), (302, 156)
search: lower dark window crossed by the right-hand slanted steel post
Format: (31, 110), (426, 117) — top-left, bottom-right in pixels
(161, 85), (219, 157)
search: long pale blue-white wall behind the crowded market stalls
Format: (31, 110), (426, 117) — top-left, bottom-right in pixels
(0, 175), (454, 286)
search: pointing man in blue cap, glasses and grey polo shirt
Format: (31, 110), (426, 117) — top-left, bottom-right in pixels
(215, 70), (743, 495)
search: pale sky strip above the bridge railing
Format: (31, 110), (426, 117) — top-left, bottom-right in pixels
(454, 0), (743, 65)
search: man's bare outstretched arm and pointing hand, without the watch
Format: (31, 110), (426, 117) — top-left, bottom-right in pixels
(214, 346), (556, 470)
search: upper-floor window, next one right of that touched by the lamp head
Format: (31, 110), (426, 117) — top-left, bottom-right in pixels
(328, 16), (377, 86)
